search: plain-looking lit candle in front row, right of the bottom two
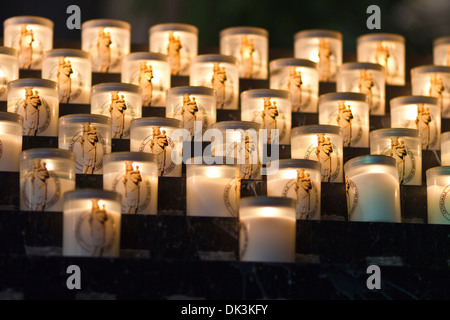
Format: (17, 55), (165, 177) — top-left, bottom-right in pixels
(239, 197), (297, 263)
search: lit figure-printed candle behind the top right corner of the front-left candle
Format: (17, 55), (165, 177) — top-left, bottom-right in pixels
(103, 152), (158, 215)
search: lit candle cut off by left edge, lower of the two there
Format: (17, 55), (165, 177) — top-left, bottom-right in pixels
(0, 112), (23, 172)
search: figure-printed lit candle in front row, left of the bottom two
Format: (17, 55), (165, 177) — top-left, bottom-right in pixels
(63, 189), (121, 258)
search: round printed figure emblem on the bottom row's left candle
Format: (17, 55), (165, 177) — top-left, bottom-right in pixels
(75, 200), (117, 257)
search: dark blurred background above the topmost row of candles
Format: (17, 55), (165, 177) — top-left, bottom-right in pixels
(0, 0), (450, 54)
